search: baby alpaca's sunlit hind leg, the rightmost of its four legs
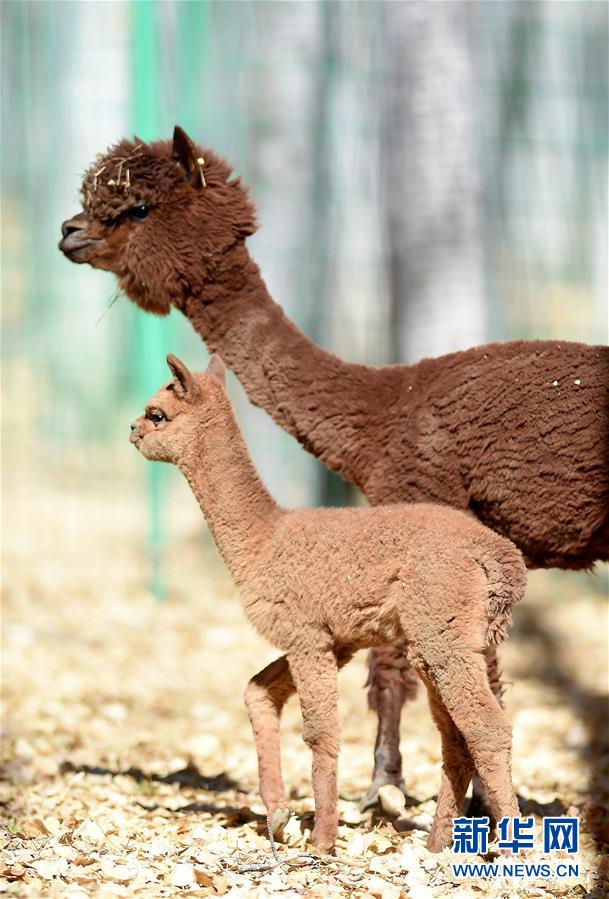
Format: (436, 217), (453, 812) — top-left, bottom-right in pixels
(427, 645), (519, 820)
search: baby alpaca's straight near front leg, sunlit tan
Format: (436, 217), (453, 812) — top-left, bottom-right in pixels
(289, 650), (338, 852)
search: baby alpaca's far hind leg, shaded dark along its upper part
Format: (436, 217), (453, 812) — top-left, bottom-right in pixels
(426, 681), (474, 852)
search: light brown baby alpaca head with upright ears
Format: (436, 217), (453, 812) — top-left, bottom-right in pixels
(129, 354), (226, 465)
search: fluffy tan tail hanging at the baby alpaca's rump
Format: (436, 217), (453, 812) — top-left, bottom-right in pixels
(476, 534), (527, 644)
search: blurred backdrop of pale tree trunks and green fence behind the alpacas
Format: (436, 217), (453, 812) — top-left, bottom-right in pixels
(2, 0), (608, 592)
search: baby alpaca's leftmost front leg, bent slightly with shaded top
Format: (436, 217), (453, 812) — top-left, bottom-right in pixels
(245, 656), (295, 829)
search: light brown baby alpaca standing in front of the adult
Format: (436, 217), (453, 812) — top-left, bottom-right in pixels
(131, 356), (526, 850)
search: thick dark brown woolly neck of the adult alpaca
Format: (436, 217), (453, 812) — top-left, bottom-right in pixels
(176, 241), (382, 485)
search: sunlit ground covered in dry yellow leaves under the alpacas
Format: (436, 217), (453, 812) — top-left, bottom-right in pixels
(0, 464), (609, 899)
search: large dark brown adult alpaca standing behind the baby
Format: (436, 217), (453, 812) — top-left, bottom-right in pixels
(60, 128), (609, 798)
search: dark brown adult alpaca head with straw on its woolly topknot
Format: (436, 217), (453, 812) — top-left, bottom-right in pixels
(59, 127), (256, 315)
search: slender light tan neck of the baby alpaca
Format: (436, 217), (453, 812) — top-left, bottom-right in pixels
(178, 398), (282, 585)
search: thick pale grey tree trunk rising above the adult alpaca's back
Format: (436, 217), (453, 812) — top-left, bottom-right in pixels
(381, 0), (486, 362)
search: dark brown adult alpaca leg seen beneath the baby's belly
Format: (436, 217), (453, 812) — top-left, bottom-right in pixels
(360, 643), (419, 811)
